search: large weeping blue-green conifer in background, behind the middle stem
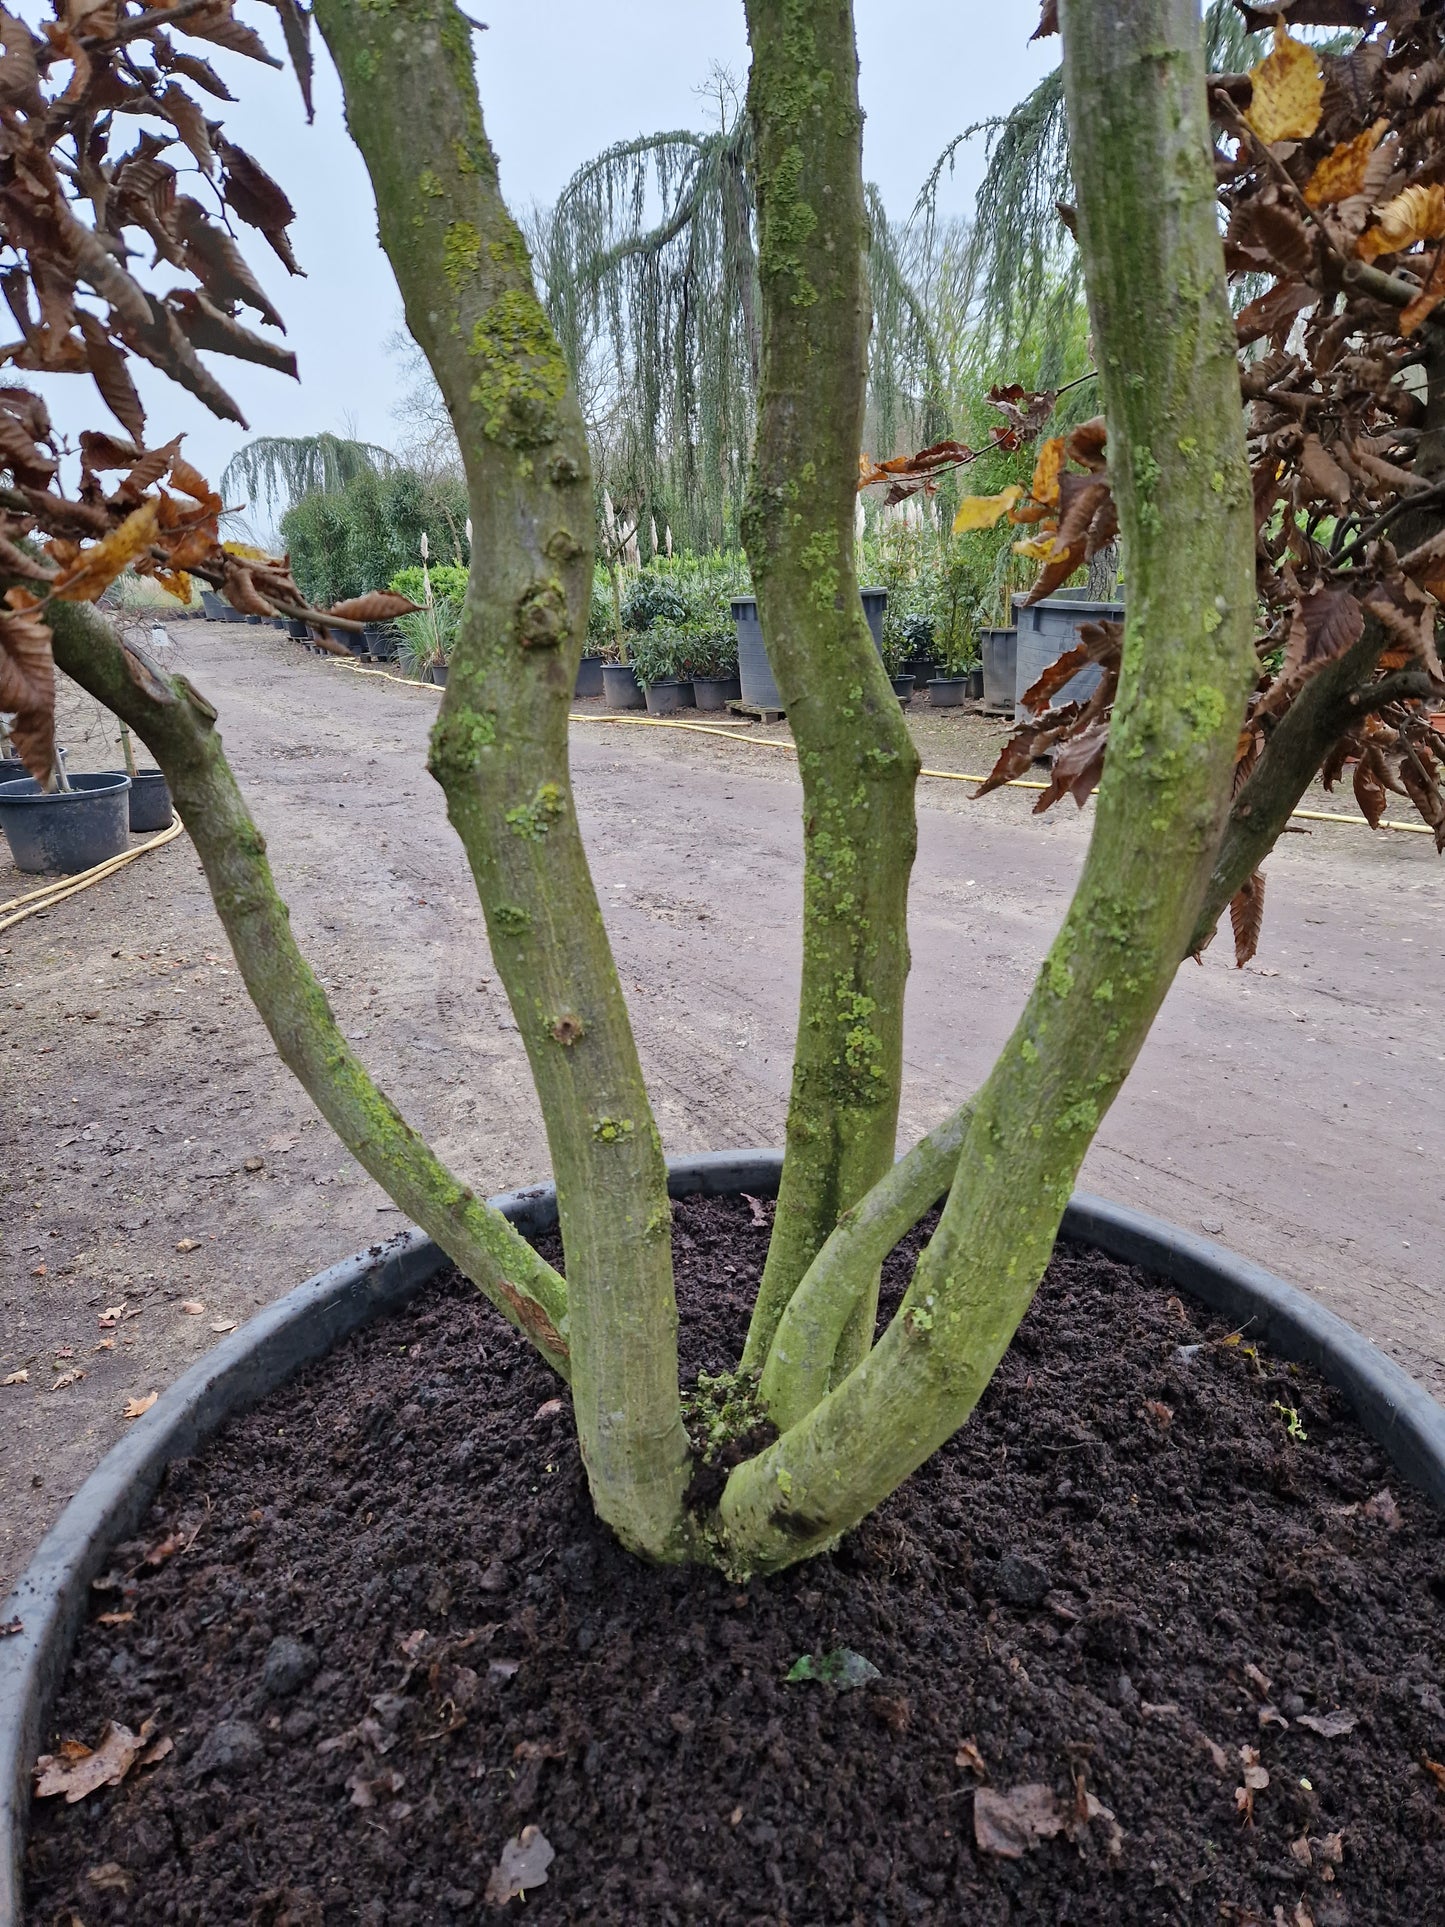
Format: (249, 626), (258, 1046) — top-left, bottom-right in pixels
(528, 86), (944, 555)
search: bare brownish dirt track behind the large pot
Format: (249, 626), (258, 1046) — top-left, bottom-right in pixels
(0, 622), (1445, 1596)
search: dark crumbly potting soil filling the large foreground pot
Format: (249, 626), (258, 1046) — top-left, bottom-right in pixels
(27, 1199), (1445, 1927)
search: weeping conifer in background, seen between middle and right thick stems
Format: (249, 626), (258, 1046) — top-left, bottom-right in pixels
(913, 0), (1260, 364)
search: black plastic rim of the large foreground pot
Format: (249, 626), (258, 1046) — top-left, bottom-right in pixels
(0, 1148), (1445, 1921)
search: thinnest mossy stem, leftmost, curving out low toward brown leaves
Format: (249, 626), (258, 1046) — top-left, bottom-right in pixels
(48, 603), (568, 1376)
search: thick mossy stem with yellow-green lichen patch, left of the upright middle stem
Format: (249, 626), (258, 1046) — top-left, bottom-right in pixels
(316, 0), (688, 1559)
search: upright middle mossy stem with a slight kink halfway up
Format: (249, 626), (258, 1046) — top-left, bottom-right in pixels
(744, 0), (919, 1368)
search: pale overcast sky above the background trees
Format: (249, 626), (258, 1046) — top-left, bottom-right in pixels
(23, 0), (1058, 497)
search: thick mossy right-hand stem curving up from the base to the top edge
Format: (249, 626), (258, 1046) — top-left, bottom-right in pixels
(717, 0), (1254, 1571)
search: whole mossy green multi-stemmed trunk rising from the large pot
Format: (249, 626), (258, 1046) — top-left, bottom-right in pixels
(56, 0), (1308, 1572)
